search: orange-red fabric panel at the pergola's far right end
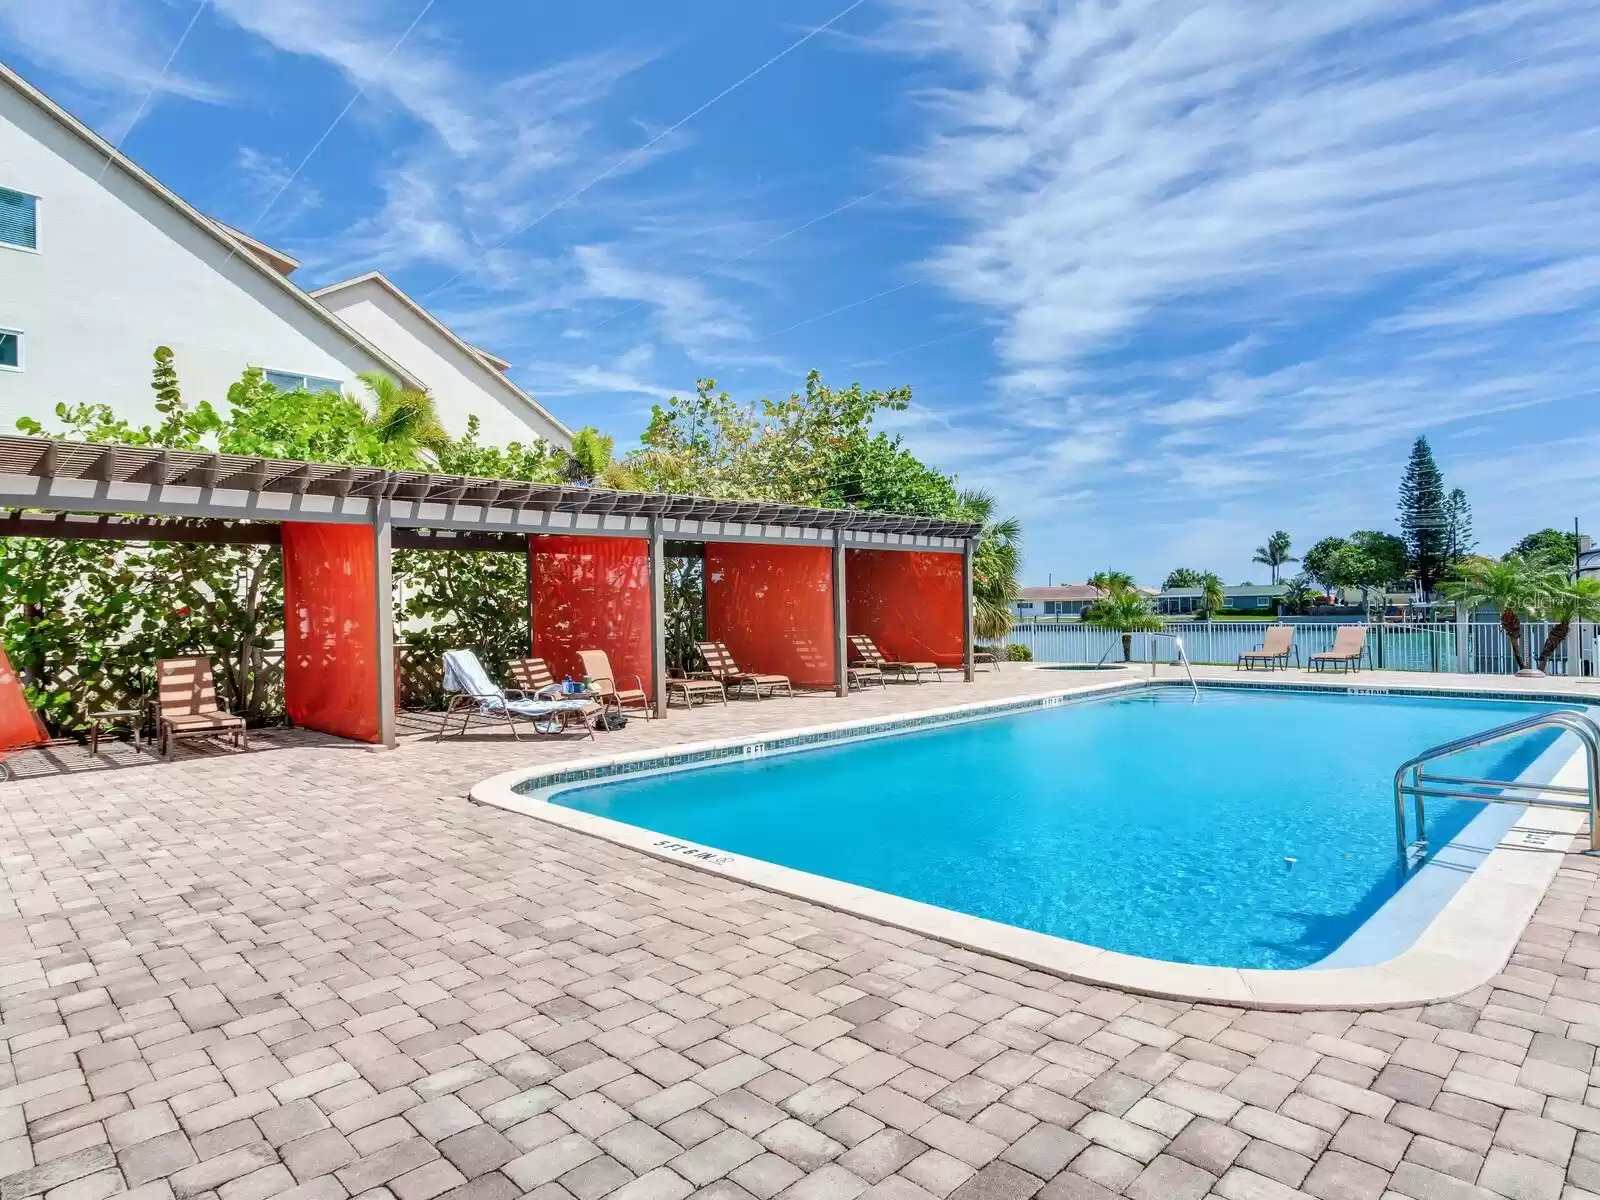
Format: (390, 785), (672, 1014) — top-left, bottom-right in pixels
(845, 550), (966, 667)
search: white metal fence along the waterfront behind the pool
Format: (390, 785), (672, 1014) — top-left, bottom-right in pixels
(1006, 621), (1597, 675)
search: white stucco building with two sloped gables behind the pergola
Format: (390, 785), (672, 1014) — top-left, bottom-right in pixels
(0, 64), (571, 445)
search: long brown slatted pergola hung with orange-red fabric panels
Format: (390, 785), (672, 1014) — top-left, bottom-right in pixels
(0, 437), (978, 746)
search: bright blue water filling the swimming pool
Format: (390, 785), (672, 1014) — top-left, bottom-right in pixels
(552, 688), (1557, 968)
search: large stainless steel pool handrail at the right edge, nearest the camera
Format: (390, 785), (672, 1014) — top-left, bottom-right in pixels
(1395, 709), (1600, 875)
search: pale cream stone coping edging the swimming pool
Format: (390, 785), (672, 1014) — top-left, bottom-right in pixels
(470, 677), (1594, 1011)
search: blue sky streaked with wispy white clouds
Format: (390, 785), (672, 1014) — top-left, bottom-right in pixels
(0, 0), (1600, 582)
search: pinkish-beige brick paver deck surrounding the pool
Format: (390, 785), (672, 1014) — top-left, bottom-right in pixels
(9, 667), (1600, 1200)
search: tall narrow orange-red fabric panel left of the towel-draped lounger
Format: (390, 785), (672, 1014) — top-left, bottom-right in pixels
(283, 522), (381, 742)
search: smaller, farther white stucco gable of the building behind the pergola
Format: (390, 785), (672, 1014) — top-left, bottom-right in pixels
(312, 270), (573, 446)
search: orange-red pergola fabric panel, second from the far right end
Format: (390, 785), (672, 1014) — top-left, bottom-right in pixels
(706, 542), (834, 688)
